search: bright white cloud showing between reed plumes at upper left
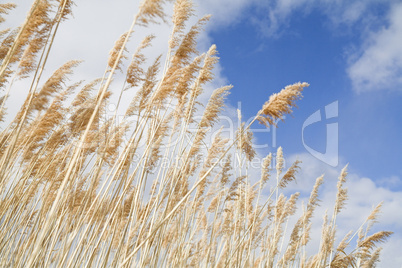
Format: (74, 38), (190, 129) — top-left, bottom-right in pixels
(1, 0), (236, 121)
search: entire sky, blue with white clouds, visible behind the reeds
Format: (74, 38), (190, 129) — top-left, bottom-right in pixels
(5, 0), (402, 268)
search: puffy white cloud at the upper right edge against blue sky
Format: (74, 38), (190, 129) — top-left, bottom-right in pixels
(348, 4), (402, 92)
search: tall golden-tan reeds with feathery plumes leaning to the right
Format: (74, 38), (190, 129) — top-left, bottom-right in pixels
(0, 0), (391, 267)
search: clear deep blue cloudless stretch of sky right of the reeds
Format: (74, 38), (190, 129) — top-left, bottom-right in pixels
(204, 1), (402, 187)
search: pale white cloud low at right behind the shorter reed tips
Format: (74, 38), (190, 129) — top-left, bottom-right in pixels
(285, 153), (402, 268)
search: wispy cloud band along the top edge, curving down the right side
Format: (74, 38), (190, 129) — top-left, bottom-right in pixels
(199, 0), (402, 92)
